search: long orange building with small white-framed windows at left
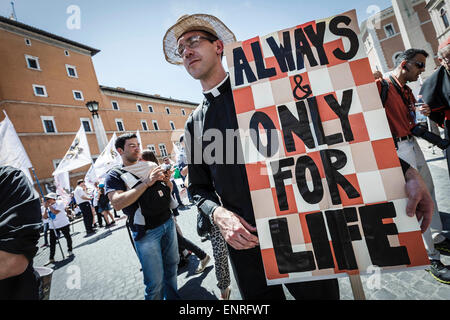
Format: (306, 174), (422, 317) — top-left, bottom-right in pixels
(0, 16), (197, 192)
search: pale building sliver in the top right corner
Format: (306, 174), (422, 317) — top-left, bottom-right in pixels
(426, 0), (450, 44)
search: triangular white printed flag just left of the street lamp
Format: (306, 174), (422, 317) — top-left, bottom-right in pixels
(53, 126), (92, 175)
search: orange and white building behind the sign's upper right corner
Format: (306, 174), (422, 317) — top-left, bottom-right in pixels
(361, 0), (439, 78)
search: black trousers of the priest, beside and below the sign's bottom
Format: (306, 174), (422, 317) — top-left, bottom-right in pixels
(228, 245), (339, 300)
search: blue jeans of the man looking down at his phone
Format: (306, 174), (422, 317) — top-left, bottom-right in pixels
(133, 218), (180, 300)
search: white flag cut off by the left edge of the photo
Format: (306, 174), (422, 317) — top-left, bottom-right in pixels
(0, 111), (33, 182)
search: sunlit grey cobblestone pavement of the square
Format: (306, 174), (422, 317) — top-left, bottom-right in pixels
(34, 141), (450, 300)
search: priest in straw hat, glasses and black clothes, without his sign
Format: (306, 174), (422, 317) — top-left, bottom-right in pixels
(163, 14), (438, 300)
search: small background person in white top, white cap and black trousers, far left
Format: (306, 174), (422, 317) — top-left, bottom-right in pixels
(43, 193), (73, 265)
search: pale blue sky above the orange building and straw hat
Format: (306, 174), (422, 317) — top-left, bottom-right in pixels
(0, 0), (391, 102)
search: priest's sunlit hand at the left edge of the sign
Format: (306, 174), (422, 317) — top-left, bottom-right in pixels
(213, 207), (259, 250)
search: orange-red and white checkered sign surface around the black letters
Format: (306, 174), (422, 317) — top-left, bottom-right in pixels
(225, 10), (428, 284)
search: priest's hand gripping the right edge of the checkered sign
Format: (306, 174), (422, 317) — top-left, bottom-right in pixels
(405, 167), (434, 233)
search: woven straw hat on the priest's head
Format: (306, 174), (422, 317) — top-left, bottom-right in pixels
(163, 14), (236, 64)
